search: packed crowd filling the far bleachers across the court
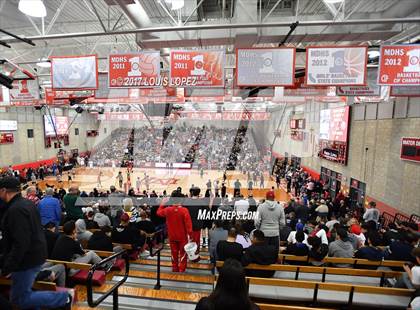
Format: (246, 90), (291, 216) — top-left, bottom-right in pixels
(90, 124), (266, 171)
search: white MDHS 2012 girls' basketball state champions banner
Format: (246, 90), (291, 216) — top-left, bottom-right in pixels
(306, 46), (368, 86)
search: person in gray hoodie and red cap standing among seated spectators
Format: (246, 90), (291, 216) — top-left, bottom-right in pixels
(255, 191), (286, 252)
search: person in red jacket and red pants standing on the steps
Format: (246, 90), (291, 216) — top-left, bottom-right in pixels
(156, 191), (192, 272)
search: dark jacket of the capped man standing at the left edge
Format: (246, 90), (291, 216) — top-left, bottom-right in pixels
(2, 194), (47, 274)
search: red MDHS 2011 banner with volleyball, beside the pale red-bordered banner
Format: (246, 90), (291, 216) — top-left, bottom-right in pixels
(108, 51), (160, 88)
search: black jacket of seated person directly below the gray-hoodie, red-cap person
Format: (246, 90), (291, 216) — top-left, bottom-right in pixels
(242, 242), (278, 278)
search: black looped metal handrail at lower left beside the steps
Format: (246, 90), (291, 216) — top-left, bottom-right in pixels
(86, 250), (130, 310)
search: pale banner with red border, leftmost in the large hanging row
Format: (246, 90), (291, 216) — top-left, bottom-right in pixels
(51, 55), (98, 90)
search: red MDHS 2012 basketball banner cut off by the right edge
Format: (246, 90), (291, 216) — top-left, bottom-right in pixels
(378, 44), (420, 86)
